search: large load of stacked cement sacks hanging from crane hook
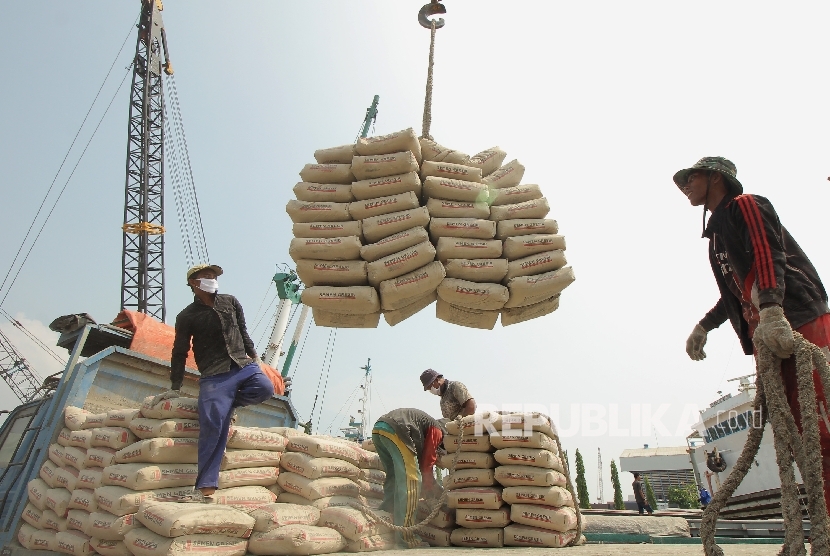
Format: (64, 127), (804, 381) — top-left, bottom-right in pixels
(286, 129), (574, 329)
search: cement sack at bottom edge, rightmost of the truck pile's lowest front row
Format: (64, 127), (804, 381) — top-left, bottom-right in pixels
(249, 525), (346, 556)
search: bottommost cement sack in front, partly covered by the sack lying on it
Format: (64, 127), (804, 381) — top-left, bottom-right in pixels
(124, 528), (248, 556)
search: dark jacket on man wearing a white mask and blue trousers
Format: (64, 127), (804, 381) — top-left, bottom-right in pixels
(170, 293), (256, 390)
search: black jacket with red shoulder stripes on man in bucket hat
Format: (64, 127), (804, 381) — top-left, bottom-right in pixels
(700, 195), (830, 355)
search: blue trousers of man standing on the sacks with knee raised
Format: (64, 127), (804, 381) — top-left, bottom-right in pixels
(196, 363), (274, 488)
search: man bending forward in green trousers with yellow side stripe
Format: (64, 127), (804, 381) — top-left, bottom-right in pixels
(372, 408), (444, 548)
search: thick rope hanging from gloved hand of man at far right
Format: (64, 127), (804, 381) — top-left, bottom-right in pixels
(700, 332), (830, 556)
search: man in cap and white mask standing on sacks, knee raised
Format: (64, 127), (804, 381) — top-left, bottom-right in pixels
(153, 264), (274, 503)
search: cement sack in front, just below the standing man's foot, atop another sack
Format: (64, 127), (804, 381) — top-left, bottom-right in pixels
(136, 501), (256, 539)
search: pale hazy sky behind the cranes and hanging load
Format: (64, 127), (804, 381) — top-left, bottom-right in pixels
(0, 0), (830, 499)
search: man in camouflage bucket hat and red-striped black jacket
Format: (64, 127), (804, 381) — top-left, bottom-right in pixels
(674, 156), (830, 507)
